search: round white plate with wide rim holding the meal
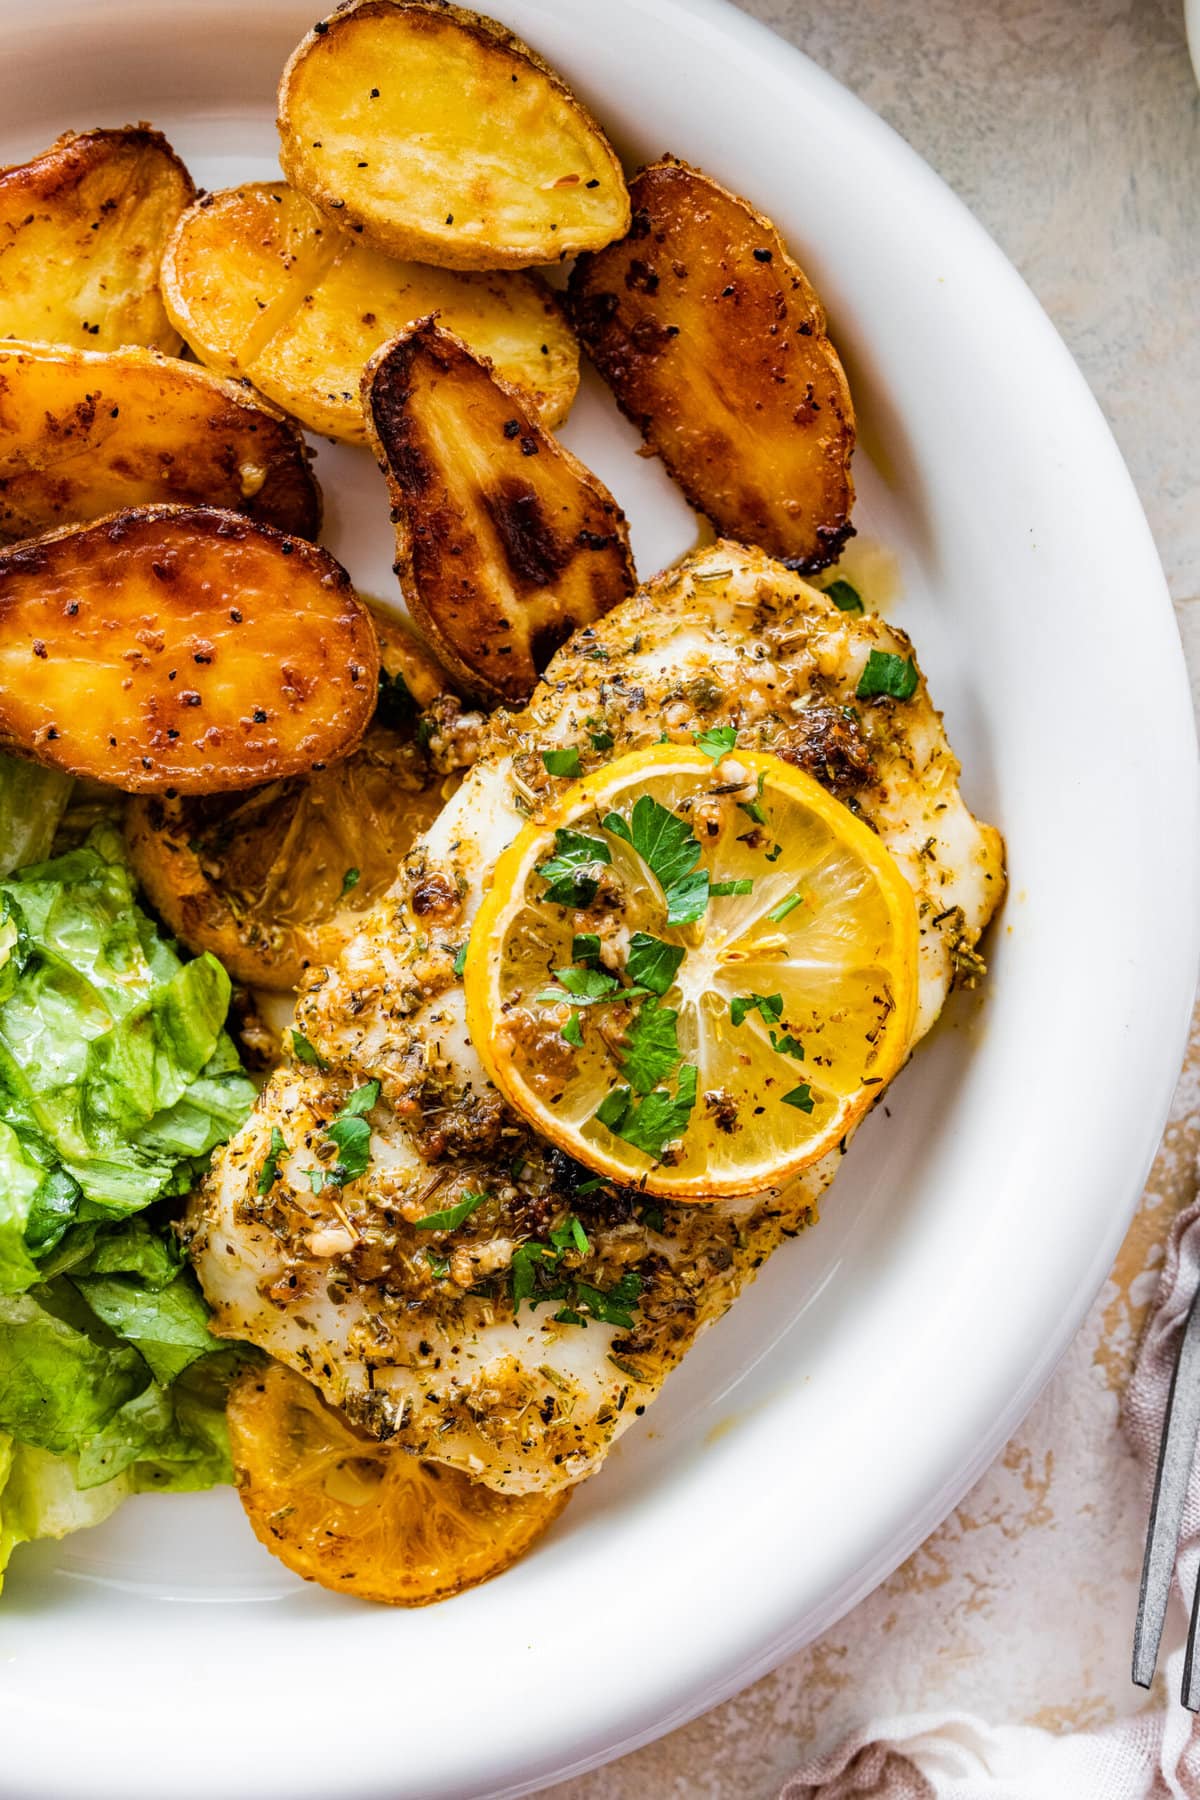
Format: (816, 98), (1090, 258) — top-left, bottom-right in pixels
(0, 0), (1200, 1800)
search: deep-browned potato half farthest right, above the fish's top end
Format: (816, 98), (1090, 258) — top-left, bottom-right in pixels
(570, 158), (855, 571)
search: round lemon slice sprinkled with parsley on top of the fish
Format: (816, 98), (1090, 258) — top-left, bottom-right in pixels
(464, 731), (918, 1201)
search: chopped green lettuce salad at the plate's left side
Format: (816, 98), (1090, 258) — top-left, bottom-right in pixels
(0, 758), (254, 1571)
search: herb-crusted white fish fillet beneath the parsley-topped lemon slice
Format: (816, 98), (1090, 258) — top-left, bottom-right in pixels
(187, 544), (1004, 1492)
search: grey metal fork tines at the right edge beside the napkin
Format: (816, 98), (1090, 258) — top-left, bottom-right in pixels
(1133, 1287), (1200, 1712)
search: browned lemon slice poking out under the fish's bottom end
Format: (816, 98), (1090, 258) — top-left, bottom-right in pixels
(228, 1363), (570, 1606)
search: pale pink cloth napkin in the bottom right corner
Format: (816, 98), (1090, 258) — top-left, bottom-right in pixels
(779, 1199), (1200, 1800)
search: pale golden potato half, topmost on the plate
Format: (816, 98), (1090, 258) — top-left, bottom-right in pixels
(279, 0), (630, 270)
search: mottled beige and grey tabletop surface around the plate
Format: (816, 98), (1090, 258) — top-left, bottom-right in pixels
(552, 0), (1200, 1800)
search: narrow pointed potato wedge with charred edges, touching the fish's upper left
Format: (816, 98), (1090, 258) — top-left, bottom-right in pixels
(363, 319), (637, 702)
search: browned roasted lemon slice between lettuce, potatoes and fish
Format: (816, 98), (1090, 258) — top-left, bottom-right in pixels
(124, 614), (455, 990)
